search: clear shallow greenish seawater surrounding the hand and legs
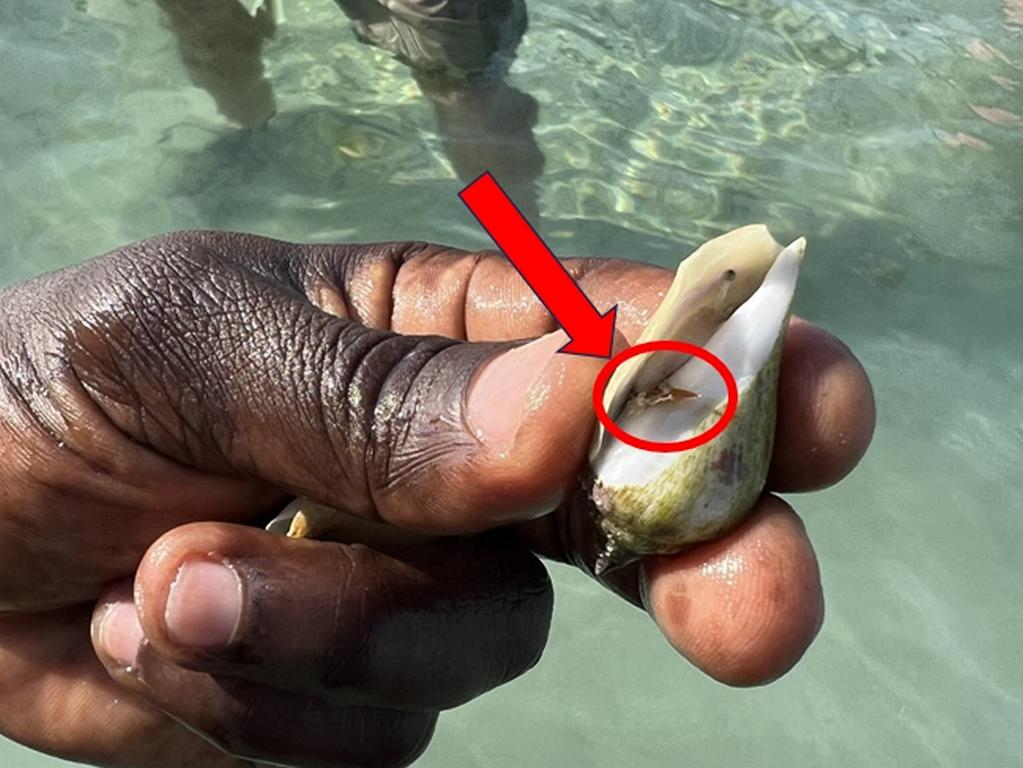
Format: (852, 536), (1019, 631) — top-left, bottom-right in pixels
(0, 0), (1023, 768)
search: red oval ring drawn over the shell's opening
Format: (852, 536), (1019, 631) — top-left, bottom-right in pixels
(593, 340), (739, 453)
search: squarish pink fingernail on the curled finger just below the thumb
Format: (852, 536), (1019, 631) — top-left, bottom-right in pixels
(165, 560), (242, 650)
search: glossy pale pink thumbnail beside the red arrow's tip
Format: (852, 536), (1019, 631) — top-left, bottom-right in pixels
(465, 330), (569, 449)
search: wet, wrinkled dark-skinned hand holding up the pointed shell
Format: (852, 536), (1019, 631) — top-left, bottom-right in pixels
(0, 232), (874, 768)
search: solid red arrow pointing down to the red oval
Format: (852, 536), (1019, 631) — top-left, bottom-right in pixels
(458, 171), (618, 357)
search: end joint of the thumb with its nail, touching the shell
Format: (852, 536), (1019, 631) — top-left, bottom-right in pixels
(370, 331), (602, 533)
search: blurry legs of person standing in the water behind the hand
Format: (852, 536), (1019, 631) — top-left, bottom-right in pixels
(158, 0), (544, 221)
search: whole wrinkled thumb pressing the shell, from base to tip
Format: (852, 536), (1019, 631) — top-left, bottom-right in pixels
(65, 243), (603, 533)
